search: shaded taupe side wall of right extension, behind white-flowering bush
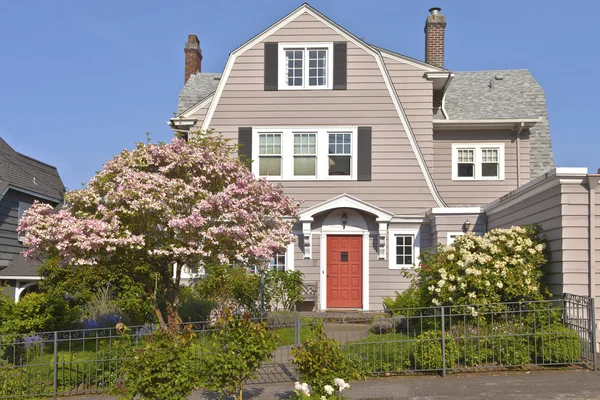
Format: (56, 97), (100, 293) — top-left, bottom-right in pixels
(487, 184), (568, 295)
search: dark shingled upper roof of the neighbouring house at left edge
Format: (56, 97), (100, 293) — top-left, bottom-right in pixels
(0, 138), (65, 202)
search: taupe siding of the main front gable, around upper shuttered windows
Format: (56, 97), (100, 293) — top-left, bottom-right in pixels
(200, 10), (436, 214)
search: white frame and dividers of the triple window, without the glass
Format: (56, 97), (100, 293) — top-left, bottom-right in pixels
(252, 126), (358, 180)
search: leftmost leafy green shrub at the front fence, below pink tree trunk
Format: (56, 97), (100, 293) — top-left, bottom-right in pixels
(119, 328), (197, 400)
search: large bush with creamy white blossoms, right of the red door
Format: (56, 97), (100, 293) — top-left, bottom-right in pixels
(413, 225), (548, 310)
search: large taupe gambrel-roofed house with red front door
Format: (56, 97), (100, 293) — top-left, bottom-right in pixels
(170, 4), (600, 344)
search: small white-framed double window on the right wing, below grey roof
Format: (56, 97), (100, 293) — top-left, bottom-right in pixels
(452, 143), (504, 180)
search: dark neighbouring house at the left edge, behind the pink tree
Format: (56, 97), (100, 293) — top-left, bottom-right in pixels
(0, 138), (65, 301)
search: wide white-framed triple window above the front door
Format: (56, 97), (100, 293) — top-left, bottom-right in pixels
(252, 127), (358, 180)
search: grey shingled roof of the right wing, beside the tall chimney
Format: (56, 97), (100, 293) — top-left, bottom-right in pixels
(434, 69), (554, 179)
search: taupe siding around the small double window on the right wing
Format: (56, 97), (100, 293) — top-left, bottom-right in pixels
(432, 131), (530, 206)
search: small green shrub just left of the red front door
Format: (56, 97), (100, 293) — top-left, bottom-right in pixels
(265, 270), (304, 311)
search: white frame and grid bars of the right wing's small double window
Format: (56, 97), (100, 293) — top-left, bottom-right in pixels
(452, 143), (505, 181)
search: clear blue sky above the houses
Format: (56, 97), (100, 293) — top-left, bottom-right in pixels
(0, 0), (600, 189)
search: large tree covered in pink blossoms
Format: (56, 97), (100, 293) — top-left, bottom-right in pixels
(18, 132), (298, 326)
